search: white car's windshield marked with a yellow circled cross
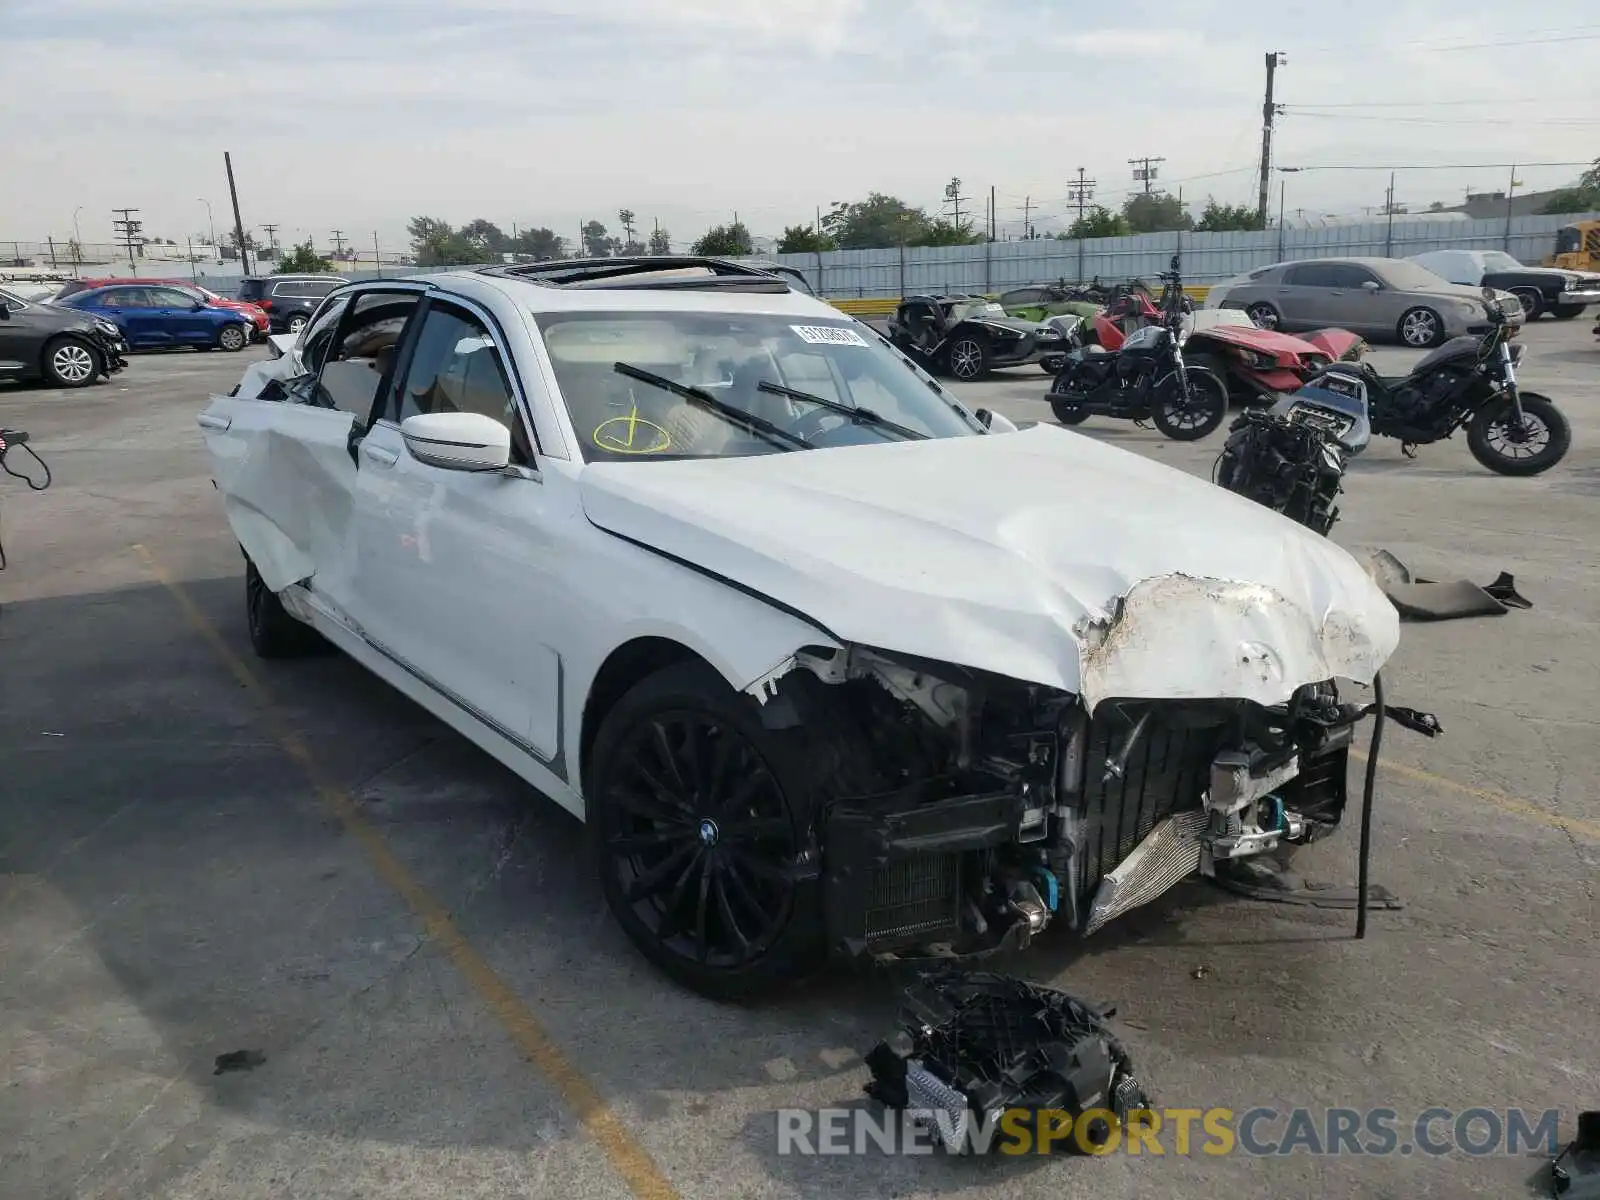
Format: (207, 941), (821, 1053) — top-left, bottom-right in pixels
(534, 312), (982, 462)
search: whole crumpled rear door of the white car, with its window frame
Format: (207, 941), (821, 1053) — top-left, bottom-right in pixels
(200, 288), (421, 627)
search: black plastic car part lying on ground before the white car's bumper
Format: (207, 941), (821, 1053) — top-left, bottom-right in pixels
(866, 971), (1150, 1152)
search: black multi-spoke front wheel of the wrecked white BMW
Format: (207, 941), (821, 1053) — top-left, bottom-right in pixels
(586, 662), (866, 1000)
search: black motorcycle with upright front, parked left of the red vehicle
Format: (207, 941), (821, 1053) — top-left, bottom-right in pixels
(1045, 254), (1227, 442)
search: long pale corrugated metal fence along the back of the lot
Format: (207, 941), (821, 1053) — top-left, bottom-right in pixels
(739, 213), (1600, 299)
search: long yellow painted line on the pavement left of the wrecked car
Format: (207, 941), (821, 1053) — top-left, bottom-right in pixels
(133, 546), (678, 1200)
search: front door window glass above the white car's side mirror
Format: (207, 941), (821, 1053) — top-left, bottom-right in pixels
(400, 302), (531, 466)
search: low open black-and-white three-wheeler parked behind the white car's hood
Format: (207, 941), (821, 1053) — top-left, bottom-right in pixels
(890, 296), (1062, 382)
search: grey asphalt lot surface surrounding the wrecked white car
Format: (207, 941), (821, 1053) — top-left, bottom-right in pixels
(0, 322), (1600, 1200)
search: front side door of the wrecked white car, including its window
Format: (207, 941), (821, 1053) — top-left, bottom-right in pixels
(354, 298), (565, 761)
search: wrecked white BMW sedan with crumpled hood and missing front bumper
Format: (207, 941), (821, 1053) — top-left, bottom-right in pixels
(200, 259), (1398, 995)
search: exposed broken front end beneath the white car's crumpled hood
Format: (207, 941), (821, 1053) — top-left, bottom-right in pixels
(802, 650), (1366, 960)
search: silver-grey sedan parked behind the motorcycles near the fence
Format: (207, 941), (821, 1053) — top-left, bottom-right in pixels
(1205, 258), (1522, 347)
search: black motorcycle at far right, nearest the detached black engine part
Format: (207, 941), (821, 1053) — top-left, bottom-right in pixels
(1307, 288), (1573, 475)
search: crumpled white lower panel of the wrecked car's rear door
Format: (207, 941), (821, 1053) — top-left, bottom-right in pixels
(200, 397), (355, 611)
